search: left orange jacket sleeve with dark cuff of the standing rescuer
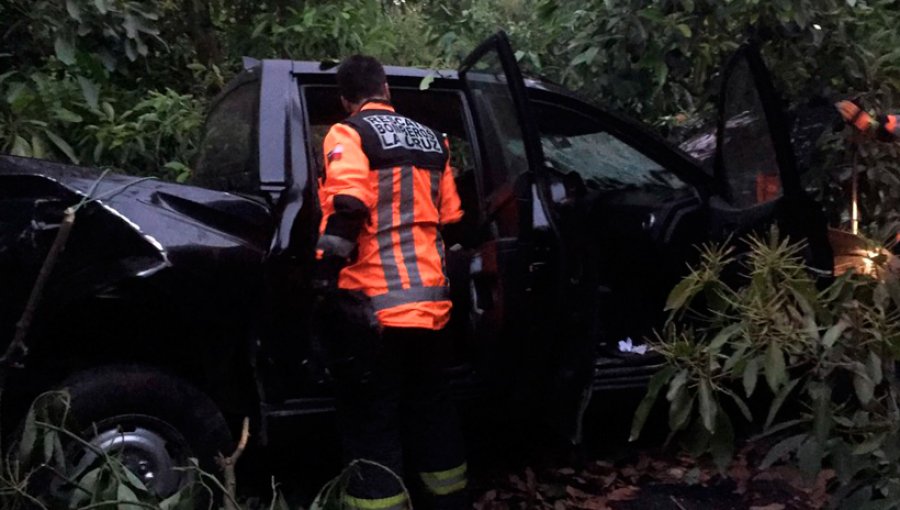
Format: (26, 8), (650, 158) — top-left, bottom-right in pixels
(316, 124), (376, 259)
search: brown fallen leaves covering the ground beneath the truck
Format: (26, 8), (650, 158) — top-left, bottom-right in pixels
(474, 444), (834, 510)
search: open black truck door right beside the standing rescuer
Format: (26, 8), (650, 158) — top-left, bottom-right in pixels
(460, 32), (591, 436)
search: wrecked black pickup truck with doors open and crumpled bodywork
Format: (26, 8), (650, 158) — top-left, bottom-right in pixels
(0, 33), (831, 494)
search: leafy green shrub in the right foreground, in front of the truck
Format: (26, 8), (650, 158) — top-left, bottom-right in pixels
(632, 233), (900, 503)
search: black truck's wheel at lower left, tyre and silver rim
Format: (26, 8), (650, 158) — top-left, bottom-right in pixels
(54, 366), (234, 498)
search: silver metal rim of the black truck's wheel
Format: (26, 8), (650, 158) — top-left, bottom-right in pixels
(72, 415), (192, 497)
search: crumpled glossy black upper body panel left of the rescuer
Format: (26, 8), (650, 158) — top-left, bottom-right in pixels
(0, 156), (273, 276)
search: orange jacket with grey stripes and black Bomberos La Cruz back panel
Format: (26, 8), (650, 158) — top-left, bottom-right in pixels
(317, 101), (463, 330)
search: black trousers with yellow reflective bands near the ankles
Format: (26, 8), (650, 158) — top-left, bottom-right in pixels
(337, 328), (466, 510)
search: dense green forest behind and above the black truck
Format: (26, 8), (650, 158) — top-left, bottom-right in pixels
(0, 0), (900, 231)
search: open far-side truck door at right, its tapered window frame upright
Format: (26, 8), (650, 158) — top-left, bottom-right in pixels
(711, 44), (831, 270)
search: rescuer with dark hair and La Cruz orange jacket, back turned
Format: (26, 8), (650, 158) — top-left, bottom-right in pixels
(315, 55), (467, 510)
